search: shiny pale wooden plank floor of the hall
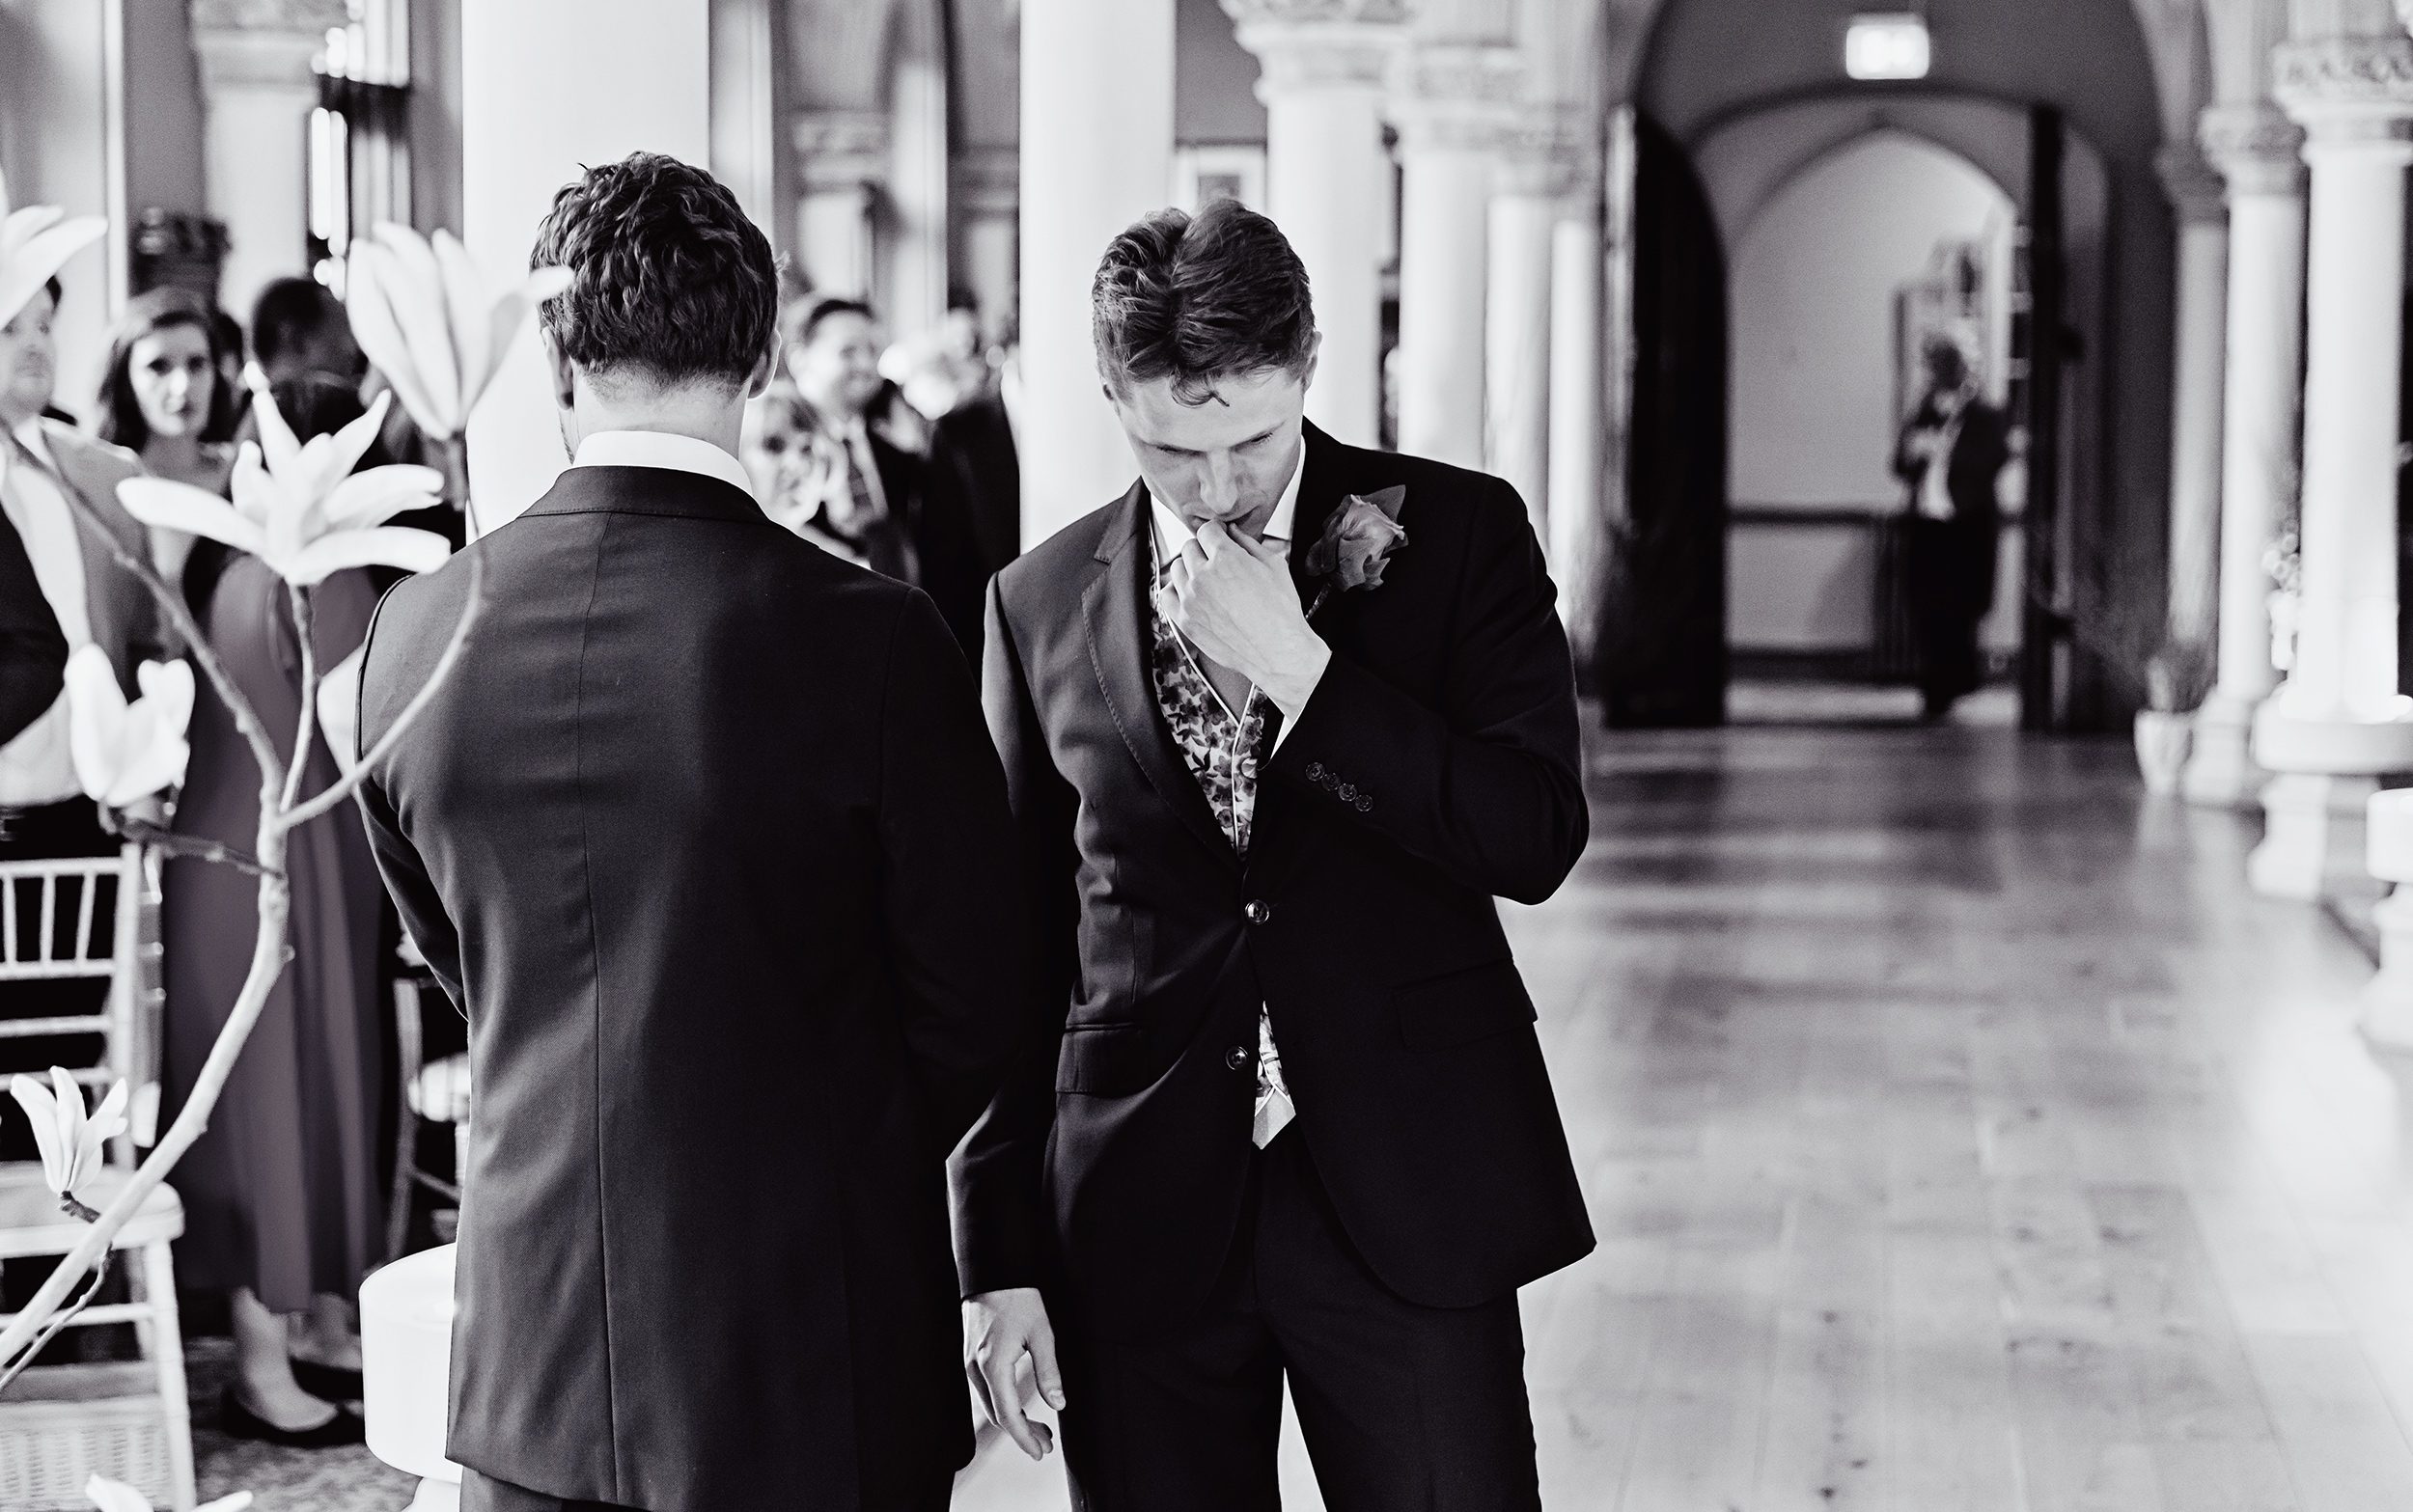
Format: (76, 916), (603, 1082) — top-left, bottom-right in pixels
(956, 726), (2413, 1512)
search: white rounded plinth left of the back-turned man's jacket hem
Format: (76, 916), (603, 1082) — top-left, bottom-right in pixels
(360, 1245), (461, 1512)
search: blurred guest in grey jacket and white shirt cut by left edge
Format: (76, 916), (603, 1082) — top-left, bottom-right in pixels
(0, 280), (164, 1123)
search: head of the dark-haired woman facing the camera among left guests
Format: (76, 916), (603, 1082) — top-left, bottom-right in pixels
(99, 287), (241, 581)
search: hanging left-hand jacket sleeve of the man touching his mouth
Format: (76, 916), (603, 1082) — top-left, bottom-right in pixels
(949, 581), (1079, 1298)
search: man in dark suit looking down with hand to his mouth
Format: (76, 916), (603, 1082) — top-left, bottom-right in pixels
(954, 203), (1593, 1512)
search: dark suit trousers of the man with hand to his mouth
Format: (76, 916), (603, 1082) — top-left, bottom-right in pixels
(1055, 1126), (1542, 1512)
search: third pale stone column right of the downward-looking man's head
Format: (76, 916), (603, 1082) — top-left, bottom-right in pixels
(1484, 111), (1576, 542)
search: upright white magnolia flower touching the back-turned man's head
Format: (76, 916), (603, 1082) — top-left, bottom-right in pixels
(346, 222), (569, 441)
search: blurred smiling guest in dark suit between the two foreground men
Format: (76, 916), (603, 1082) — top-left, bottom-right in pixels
(770, 299), (987, 656)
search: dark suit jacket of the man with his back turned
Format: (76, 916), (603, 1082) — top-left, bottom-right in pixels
(360, 468), (1028, 1512)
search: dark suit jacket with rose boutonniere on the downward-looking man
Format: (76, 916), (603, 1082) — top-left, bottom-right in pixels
(954, 426), (1593, 1336)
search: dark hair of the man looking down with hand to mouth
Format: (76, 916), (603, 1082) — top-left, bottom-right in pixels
(1089, 200), (1316, 405)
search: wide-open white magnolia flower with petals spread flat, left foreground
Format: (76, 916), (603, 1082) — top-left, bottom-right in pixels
(119, 381), (452, 589)
